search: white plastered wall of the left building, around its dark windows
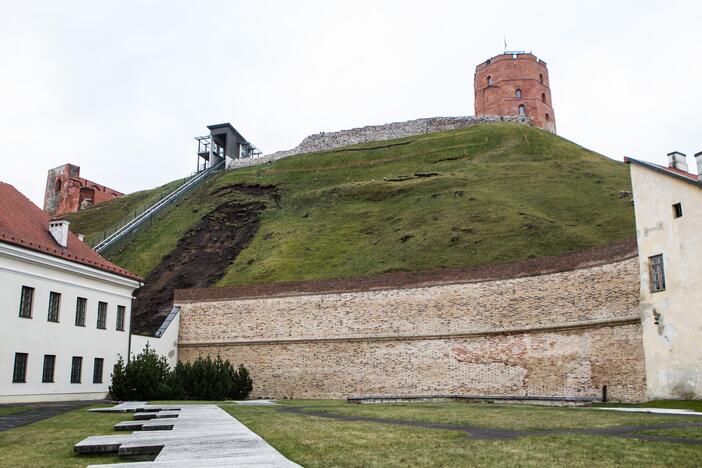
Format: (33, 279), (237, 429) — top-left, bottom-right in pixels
(0, 243), (139, 403)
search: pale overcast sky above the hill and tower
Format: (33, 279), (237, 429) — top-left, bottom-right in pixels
(0, 0), (702, 206)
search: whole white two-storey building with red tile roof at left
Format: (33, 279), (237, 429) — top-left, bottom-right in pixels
(0, 182), (141, 403)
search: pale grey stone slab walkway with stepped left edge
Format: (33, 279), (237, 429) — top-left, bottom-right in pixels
(74, 403), (299, 468)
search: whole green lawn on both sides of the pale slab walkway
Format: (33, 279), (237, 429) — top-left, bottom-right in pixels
(0, 400), (702, 467)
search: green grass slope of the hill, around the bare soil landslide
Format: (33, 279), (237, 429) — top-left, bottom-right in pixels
(66, 123), (634, 285)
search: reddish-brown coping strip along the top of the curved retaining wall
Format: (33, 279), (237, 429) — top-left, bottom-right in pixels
(174, 238), (637, 304)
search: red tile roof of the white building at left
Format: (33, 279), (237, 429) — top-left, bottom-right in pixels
(0, 182), (143, 281)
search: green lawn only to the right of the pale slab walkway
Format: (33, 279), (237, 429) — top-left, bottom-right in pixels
(223, 401), (702, 467)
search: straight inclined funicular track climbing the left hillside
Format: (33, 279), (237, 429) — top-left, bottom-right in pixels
(88, 161), (224, 253)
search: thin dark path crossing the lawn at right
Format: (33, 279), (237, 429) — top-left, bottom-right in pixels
(278, 406), (702, 445)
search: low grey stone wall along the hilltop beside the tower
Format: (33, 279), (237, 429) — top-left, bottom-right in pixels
(227, 115), (531, 169)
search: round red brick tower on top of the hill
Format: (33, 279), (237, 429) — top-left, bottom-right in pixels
(474, 52), (556, 133)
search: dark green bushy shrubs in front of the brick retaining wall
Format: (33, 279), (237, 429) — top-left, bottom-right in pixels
(110, 344), (253, 401)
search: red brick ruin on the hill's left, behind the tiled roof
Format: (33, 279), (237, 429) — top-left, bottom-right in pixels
(44, 164), (124, 217)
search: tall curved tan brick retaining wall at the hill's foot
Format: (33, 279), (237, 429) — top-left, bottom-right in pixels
(176, 245), (645, 401)
